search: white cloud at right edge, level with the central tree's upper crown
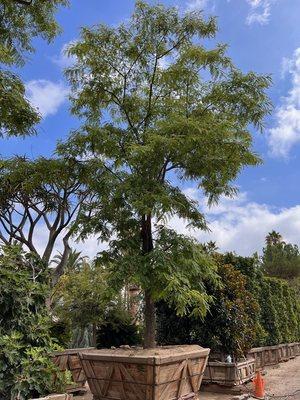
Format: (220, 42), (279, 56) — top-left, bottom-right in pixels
(268, 47), (300, 158)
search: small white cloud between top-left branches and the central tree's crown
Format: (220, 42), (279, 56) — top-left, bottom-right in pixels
(26, 79), (68, 118)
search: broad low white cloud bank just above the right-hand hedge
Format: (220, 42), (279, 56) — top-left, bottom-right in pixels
(169, 189), (300, 255)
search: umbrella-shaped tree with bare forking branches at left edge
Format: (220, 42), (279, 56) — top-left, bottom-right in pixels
(0, 157), (88, 284)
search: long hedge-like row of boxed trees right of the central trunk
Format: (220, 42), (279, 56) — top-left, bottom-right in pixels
(157, 253), (300, 357)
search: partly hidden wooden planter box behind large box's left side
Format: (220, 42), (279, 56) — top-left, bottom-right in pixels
(53, 347), (95, 388)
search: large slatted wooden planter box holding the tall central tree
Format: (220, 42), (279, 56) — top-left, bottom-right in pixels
(80, 345), (210, 400)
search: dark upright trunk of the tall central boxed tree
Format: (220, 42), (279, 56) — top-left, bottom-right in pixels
(141, 214), (156, 349)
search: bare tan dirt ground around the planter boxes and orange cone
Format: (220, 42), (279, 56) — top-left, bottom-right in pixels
(74, 357), (300, 400)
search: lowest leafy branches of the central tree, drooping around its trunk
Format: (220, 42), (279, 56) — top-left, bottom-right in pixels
(98, 226), (219, 317)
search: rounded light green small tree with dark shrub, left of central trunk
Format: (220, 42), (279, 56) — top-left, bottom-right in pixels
(52, 259), (140, 348)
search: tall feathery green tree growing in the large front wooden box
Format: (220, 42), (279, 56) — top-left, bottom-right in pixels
(61, 1), (271, 347)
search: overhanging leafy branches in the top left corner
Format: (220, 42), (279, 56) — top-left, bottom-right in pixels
(0, 0), (68, 137)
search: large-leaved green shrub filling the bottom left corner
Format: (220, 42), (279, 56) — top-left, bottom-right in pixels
(0, 246), (66, 400)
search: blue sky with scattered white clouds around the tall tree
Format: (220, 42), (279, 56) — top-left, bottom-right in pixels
(0, 0), (300, 255)
